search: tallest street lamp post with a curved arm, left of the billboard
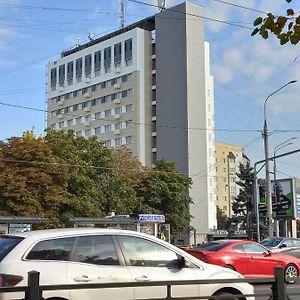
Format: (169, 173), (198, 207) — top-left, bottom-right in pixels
(262, 80), (297, 237)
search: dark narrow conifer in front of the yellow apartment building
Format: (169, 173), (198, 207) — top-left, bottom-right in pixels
(232, 162), (255, 238)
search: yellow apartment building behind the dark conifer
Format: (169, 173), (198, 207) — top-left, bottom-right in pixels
(215, 142), (249, 217)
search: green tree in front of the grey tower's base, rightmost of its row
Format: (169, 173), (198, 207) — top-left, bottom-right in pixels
(137, 160), (192, 235)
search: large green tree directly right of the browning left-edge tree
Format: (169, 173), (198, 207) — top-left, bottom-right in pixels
(44, 130), (115, 219)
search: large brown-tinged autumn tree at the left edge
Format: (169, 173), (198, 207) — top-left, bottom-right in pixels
(0, 132), (68, 228)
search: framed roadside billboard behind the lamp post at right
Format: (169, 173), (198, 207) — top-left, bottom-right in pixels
(258, 178), (296, 220)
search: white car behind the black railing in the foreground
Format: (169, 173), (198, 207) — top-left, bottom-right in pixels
(0, 228), (254, 300)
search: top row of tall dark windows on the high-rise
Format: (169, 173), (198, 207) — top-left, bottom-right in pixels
(50, 39), (132, 89)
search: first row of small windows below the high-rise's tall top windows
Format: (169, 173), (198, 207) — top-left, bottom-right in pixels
(49, 73), (133, 104)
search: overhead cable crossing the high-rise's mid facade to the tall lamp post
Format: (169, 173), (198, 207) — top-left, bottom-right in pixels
(0, 102), (261, 132)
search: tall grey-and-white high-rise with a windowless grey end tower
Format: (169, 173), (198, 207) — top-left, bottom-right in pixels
(47, 3), (216, 239)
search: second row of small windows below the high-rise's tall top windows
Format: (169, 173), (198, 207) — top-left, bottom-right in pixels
(50, 89), (133, 118)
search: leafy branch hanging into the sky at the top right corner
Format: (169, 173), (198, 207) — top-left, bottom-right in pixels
(251, 0), (300, 45)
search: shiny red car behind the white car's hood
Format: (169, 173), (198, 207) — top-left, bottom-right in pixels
(184, 240), (300, 278)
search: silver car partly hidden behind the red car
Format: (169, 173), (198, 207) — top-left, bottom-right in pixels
(261, 237), (300, 258)
